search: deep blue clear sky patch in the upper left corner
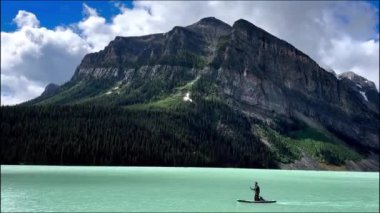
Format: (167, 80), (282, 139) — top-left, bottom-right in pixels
(1, 0), (132, 32)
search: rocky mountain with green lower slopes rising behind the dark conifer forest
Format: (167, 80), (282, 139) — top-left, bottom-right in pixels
(8, 18), (380, 170)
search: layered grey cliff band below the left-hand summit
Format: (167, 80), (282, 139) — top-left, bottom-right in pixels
(73, 18), (231, 80)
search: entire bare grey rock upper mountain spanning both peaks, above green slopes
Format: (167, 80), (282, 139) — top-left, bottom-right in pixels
(34, 18), (380, 155)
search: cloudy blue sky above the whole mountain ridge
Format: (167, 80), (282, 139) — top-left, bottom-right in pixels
(0, 0), (379, 105)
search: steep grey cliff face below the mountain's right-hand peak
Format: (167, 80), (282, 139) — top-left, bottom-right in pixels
(209, 20), (379, 150)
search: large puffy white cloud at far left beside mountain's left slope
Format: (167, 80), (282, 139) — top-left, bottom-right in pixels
(1, 11), (91, 105)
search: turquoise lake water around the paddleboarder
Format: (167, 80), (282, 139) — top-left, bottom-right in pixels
(1, 166), (379, 212)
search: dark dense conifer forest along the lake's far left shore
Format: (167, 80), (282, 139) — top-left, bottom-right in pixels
(1, 101), (276, 168)
